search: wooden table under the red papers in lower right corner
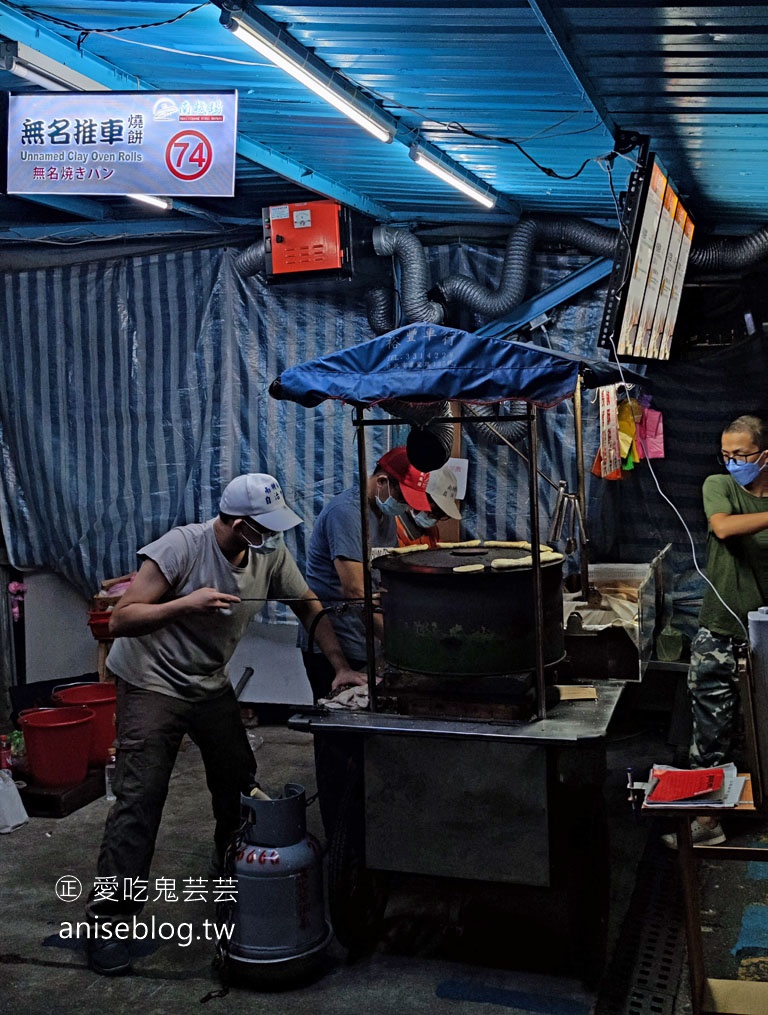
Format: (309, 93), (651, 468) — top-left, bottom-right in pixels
(642, 775), (768, 1015)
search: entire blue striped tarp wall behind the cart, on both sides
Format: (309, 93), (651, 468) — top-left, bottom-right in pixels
(0, 244), (754, 633)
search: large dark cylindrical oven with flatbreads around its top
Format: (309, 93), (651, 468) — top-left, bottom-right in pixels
(373, 545), (564, 676)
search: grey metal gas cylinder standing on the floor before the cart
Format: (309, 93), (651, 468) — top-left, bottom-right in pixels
(220, 783), (333, 979)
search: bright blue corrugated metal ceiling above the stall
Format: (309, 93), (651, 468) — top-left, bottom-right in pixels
(0, 0), (768, 232)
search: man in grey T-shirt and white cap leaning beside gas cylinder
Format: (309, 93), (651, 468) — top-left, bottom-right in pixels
(86, 473), (364, 975)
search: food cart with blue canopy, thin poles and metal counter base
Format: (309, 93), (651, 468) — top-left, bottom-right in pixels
(270, 324), (639, 980)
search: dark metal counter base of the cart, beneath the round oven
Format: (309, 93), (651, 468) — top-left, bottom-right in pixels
(288, 681), (624, 982)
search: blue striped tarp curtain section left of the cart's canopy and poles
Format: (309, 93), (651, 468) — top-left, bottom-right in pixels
(0, 249), (377, 617)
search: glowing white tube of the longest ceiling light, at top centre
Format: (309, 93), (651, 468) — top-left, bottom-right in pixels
(227, 16), (395, 144)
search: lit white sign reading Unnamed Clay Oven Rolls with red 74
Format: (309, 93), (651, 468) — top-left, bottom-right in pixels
(7, 91), (237, 197)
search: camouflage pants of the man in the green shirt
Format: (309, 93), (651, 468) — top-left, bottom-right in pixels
(688, 627), (740, 768)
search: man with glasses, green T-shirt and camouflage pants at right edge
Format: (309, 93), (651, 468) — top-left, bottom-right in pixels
(664, 416), (768, 847)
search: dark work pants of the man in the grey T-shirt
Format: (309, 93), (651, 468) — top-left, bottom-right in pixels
(87, 679), (256, 917)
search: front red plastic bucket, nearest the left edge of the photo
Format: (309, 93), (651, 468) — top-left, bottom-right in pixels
(18, 705), (94, 788)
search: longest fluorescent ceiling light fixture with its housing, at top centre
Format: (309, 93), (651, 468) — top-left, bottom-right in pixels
(222, 12), (397, 144)
